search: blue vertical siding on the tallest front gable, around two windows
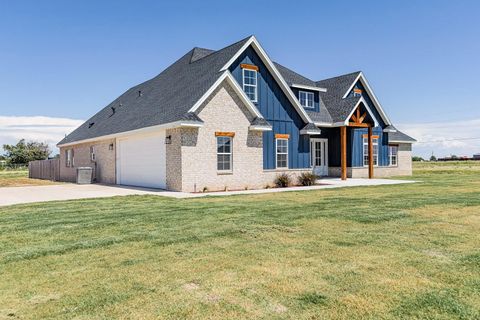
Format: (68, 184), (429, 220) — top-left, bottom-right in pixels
(230, 47), (310, 169)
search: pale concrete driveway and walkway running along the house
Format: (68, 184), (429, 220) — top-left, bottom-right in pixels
(0, 178), (415, 206)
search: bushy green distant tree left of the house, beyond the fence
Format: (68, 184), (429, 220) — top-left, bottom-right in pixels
(3, 139), (52, 164)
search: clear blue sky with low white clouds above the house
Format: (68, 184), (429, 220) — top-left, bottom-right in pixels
(0, 0), (480, 155)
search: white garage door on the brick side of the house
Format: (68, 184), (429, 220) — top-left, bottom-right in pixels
(117, 130), (166, 189)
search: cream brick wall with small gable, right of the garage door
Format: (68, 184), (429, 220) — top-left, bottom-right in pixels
(167, 83), (310, 192)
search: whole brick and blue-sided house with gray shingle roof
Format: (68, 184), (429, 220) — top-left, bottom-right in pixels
(58, 36), (415, 192)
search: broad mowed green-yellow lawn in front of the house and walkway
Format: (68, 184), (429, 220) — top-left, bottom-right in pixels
(0, 162), (480, 319)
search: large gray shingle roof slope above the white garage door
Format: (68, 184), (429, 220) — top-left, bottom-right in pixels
(59, 38), (249, 144)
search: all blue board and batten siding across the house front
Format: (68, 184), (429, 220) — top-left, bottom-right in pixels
(230, 47), (389, 169)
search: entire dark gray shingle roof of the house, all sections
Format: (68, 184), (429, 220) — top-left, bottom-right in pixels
(59, 37), (404, 144)
